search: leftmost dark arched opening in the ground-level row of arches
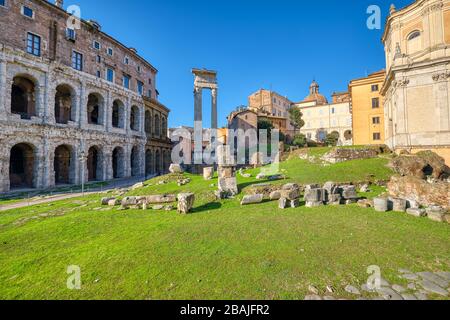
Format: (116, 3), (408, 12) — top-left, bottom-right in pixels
(9, 143), (36, 189)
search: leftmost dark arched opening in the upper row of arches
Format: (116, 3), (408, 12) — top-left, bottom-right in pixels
(11, 76), (37, 120)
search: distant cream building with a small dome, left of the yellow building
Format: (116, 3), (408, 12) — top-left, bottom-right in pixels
(293, 81), (353, 145)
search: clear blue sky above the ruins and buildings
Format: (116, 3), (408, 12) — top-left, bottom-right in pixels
(69, 0), (413, 127)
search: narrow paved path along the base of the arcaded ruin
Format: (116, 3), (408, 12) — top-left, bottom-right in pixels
(0, 179), (143, 211)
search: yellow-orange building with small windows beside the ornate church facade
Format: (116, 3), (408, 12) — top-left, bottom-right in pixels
(349, 70), (386, 145)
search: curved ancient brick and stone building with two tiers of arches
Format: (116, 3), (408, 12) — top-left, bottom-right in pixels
(0, 0), (170, 192)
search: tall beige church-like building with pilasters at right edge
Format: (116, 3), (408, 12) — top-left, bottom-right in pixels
(382, 0), (450, 163)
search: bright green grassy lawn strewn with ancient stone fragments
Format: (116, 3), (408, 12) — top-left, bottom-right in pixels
(0, 151), (450, 299)
